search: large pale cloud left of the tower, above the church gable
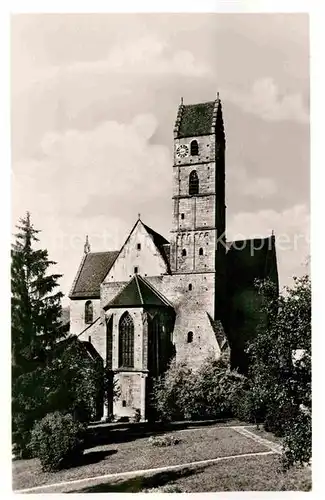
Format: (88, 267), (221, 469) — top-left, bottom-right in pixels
(12, 114), (172, 300)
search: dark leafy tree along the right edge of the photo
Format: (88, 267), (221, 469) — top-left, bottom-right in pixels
(248, 275), (311, 465)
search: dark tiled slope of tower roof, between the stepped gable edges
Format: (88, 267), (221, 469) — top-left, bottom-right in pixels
(178, 101), (215, 137)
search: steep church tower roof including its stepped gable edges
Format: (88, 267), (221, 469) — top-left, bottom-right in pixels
(174, 95), (224, 139)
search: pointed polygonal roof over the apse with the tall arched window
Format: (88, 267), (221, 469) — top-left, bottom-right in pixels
(104, 274), (172, 311)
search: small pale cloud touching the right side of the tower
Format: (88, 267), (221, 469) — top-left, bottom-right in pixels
(227, 166), (277, 198)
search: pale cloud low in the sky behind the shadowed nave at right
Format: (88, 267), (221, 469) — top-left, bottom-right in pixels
(227, 204), (310, 286)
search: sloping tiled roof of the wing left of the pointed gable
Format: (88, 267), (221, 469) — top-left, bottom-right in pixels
(69, 251), (119, 299)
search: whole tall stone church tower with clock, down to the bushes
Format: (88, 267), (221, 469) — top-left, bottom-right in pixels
(170, 94), (226, 365)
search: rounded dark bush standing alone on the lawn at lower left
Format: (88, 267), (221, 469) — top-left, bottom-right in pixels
(29, 412), (85, 471)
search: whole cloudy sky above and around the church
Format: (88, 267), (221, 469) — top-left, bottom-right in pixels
(11, 13), (310, 303)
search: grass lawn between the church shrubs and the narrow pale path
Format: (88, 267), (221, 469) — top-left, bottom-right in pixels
(13, 426), (268, 490)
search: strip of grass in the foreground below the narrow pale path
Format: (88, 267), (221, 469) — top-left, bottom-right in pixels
(24, 455), (311, 493)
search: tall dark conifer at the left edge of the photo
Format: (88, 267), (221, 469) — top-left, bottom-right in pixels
(11, 212), (63, 453)
